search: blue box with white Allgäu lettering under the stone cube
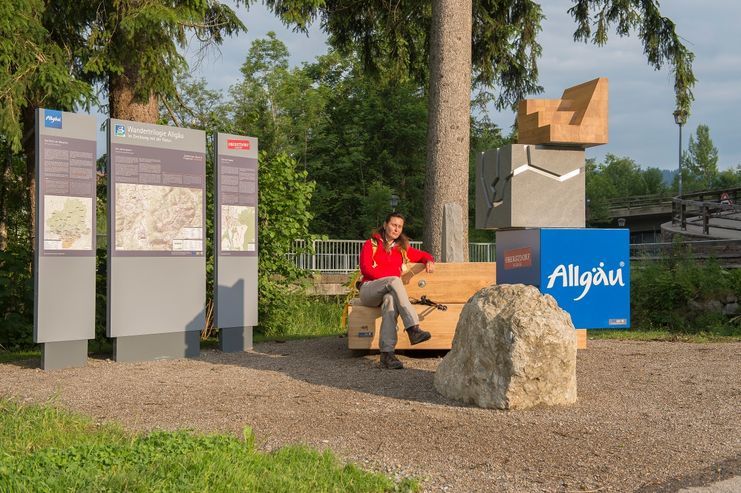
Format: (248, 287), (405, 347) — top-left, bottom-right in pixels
(497, 228), (630, 329)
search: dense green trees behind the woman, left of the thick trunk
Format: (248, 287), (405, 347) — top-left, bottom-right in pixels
(230, 33), (427, 238)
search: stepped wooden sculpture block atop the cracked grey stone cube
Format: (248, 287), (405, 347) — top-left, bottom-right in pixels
(517, 77), (607, 147)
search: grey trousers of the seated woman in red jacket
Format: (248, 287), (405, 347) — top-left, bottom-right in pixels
(360, 276), (419, 352)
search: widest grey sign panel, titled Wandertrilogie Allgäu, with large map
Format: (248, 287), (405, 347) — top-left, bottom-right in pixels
(108, 119), (206, 340)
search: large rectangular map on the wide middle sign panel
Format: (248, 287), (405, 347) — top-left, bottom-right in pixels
(115, 183), (203, 252)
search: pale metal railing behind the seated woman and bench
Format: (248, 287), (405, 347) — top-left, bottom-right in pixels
(289, 240), (496, 273)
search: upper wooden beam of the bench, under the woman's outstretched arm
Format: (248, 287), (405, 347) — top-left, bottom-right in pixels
(402, 262), (497, 304)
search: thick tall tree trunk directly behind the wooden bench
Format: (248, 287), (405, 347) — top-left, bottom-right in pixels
(423, 0), (472, 260)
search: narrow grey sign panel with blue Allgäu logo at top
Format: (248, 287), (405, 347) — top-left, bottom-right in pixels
(34, 108), (96, 345)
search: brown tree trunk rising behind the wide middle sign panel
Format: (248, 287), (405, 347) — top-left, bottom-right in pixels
(108, 67), (159, 123)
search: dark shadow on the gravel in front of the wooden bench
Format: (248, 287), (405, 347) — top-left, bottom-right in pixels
(201, 337), (461, 407)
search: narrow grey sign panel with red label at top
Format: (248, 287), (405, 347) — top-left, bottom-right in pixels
(214, 133), (258, 329)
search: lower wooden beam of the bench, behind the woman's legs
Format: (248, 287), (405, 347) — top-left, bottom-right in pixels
(347, 304), (464, 349)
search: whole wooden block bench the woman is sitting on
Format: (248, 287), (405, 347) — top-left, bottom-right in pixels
(347, 262), (497, 349)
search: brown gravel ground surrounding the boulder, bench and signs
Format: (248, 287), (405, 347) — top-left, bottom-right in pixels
(0, 337), (741, 492)
